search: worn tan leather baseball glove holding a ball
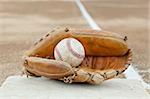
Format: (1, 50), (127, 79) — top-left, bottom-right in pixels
(23, 28), (132, 84)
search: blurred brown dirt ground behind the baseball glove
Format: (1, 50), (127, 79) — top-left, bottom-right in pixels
(0, 0), (150, 89)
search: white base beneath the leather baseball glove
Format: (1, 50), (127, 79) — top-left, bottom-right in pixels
(0, 76), (150, 99)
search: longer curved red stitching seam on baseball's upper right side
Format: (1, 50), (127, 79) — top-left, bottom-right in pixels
(66, 39), (84, 58)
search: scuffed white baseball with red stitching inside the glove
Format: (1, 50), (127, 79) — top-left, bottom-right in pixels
(54, 38), (85, 67)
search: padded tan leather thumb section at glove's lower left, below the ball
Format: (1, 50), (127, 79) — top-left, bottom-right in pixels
(24, 57), (74, 79)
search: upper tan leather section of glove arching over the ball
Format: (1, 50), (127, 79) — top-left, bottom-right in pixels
(25, 28), (128, 58)
